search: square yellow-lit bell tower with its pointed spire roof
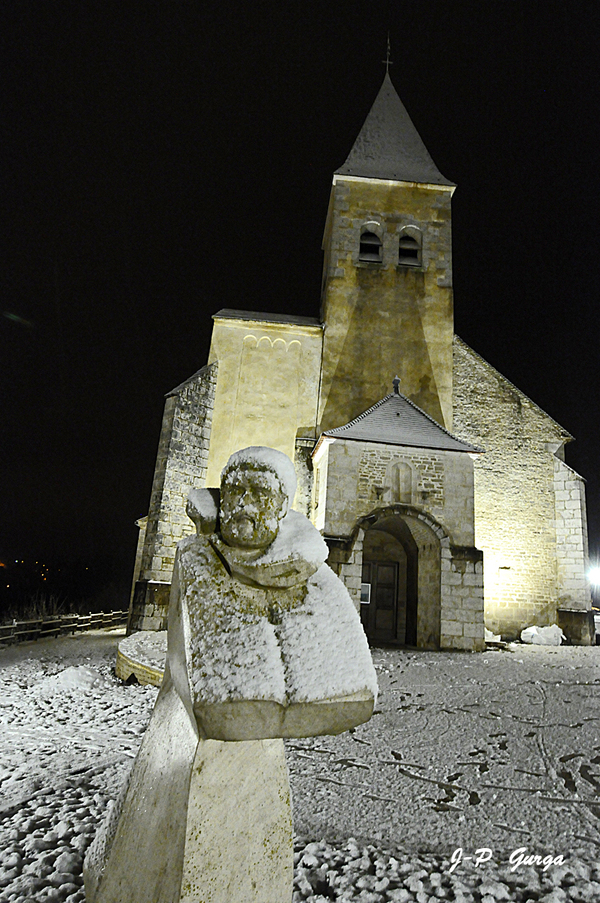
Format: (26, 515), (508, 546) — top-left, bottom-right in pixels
(319, 72), (455, 431)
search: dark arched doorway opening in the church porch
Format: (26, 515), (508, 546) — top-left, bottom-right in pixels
(361, 505), (443, 649)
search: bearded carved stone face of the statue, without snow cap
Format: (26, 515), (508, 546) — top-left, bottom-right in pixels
(221, 466), (287, 549)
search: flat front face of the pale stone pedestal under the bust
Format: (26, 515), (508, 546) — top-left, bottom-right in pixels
(180, 740), (294, 903)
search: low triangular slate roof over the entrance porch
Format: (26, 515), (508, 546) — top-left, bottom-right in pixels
(323, 392), (483, 452)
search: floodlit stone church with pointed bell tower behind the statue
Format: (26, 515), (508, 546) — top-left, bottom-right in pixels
(130, 74), (593, 650)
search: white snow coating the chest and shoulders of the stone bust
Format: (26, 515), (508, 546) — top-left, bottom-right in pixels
(180, 528), (377, 705)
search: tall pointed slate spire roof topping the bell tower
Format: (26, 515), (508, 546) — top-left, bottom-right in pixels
(336, 73), (455, 186)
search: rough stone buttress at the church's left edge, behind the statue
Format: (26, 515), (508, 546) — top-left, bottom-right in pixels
(128, 364), (217, 631)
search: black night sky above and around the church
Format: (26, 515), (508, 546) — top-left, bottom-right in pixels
(0, 0), (600, 604)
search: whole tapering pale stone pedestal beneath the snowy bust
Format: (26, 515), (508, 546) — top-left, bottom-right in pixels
(84, 686), (293, 903)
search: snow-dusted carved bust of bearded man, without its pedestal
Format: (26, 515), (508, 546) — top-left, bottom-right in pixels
(177, 448), (376, 740)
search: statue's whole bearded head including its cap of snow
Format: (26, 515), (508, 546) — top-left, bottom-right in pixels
(220, 445), (296, 550)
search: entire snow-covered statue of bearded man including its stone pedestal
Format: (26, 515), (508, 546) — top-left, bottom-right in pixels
(84, 447), (377, 903)
